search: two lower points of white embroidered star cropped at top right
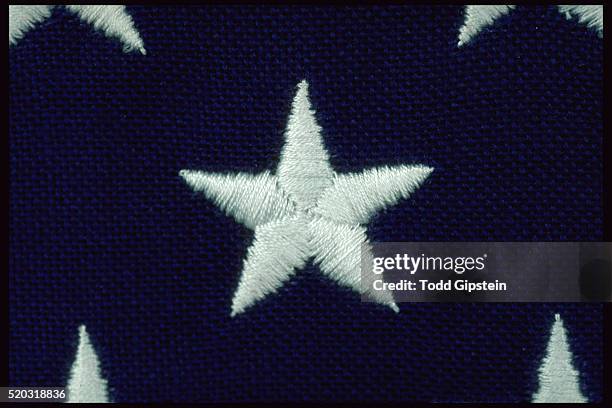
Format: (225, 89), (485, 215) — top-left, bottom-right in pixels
(457, 5), (603, 47)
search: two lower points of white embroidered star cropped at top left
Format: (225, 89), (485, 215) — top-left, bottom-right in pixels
(9, 5), (146, 54)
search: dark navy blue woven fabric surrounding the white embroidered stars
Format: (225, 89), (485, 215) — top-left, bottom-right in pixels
(9, 6), (603, 402)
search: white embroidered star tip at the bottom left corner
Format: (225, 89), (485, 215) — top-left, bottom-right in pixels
(66, 325), (109, 402)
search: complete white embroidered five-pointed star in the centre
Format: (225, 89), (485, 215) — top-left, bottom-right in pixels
(180, 81), (433, 316)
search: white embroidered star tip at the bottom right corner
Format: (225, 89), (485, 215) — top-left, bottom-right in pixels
(533, 314), (588, 403)
